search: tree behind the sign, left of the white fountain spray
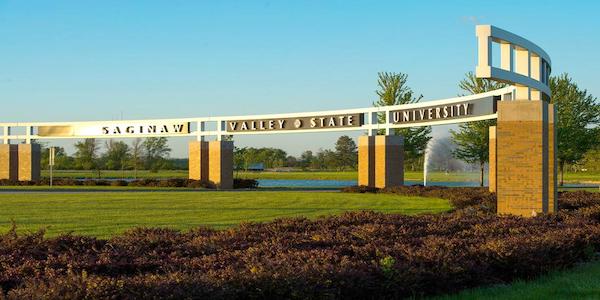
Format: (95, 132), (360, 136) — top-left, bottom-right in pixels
(373, 72), (431, 169)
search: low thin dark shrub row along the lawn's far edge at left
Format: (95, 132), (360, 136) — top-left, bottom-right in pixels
(0, 178), (258, 189)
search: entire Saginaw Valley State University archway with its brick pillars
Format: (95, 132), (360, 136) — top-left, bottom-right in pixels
(0, 25), (556, 216)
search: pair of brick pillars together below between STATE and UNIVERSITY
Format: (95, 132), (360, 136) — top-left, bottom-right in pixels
(358, 135), (404, 188)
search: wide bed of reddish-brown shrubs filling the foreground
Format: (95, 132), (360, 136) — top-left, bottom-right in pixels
(0, 188), (600, 299)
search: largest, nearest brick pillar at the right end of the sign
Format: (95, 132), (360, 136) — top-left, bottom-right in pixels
(496, 100), (556, 216)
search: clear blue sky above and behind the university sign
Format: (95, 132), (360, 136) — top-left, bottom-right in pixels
(0, 0), (600, 157)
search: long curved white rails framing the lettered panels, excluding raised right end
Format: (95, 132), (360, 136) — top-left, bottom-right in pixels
(0, 87), (515, 143)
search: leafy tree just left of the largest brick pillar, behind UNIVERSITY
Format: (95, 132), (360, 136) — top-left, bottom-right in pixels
(450, 72), (506, 186)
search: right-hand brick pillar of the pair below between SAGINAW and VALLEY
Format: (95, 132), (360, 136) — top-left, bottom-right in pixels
(208, 141), (233, 189)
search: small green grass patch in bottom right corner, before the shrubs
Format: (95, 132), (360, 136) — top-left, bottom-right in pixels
(435, 261), (600, 300)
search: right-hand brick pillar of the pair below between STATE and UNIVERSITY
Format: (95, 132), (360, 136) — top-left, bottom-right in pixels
(375, 135), (404, 188)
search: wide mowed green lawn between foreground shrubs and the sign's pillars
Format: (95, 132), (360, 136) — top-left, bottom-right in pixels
(0, 191), (450, 238)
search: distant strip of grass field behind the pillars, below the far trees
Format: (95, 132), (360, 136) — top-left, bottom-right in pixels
(42, 170), (600, 183)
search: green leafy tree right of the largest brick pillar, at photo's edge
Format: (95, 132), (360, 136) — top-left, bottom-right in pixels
(550, 73), (600, 186)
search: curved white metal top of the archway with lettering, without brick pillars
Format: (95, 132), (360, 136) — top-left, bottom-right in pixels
(0, 25), (550, 144)
